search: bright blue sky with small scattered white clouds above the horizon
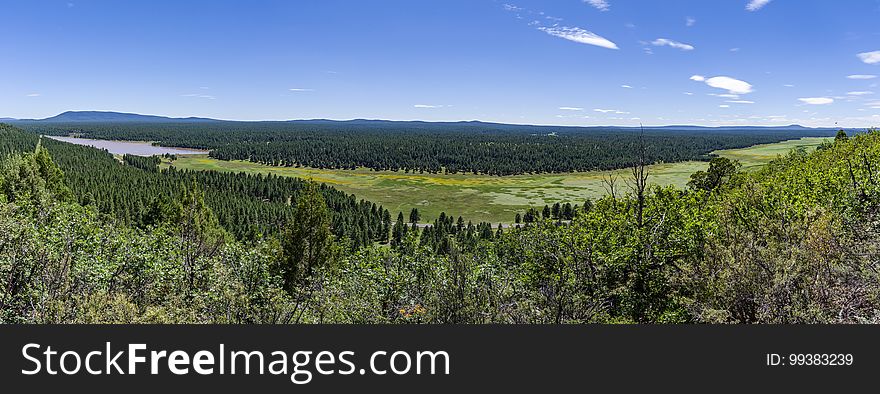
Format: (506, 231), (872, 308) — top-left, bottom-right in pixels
(0, 0), (880, 127)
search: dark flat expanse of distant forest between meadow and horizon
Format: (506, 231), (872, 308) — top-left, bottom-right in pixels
(20, 121), (830, 175)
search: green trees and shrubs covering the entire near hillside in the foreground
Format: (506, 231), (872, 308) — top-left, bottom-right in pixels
(0, 126), (880, 323)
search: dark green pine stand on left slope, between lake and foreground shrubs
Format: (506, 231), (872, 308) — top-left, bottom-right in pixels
(0, 125), (391, 249)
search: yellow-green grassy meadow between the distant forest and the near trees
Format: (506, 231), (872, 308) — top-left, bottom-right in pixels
(163, 138), (825, 223)
